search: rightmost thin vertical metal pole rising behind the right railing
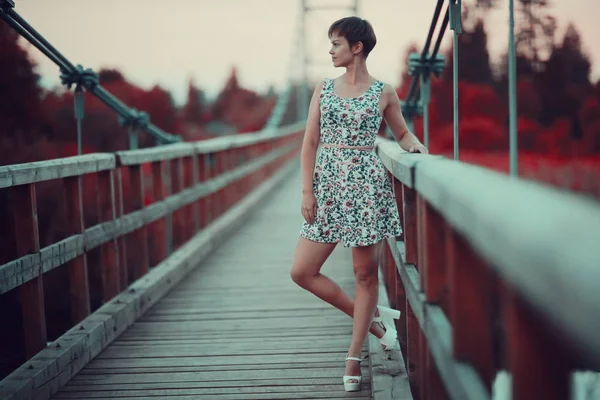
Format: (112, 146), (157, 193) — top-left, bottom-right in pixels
(508, 0), (519, 176)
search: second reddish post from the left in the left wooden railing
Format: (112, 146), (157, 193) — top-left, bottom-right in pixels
(63, 176), (90, 325)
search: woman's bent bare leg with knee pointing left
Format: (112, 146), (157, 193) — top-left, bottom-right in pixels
(290, 237), (385, 338)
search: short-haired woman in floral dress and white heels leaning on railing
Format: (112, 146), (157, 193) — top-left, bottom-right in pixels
(291, 17), (427, 391)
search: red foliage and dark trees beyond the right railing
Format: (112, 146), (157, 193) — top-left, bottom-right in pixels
(397, 7), (600, 198)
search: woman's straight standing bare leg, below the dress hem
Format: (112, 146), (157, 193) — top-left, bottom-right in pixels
(346, 242), (381, 382)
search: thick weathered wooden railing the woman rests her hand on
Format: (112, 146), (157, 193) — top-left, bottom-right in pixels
(377, 139), (600, 400)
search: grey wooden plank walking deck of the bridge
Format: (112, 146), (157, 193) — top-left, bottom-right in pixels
(53, 173), (371, 400)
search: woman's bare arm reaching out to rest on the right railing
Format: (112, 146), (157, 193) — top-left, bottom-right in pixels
(381, 84), (429, 154)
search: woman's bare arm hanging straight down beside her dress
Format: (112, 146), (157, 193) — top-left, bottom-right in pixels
(300, 82), (323, 194)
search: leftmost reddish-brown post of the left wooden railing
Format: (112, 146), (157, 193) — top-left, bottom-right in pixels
(11, 183), (47, 358)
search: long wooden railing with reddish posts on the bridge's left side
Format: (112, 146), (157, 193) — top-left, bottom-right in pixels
(0, 124), (303, 393)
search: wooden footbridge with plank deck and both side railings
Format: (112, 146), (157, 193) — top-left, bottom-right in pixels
(0, 125), (600, 400)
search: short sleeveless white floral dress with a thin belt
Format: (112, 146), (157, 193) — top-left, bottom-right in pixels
(300, 78), (402, 247)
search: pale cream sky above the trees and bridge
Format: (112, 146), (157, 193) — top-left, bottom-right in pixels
(10, 0), (600, 104)
